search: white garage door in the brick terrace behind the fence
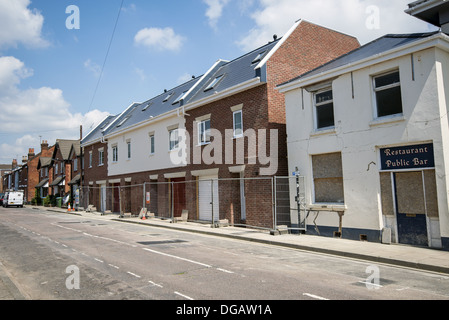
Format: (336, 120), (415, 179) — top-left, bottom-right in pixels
(198, 176), (219, 222)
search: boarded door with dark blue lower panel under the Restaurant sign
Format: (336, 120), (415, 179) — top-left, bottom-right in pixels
(394, 171), (429, 246)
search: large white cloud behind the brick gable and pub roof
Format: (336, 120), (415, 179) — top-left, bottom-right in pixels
(238, 0), (436, 51)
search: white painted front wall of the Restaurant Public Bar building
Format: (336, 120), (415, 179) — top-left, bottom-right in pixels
(285, 48), (449, 245)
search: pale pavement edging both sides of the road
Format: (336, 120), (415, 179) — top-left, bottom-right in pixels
(0, 207), (449, 300)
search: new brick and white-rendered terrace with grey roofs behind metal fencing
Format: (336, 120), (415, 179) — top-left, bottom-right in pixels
(81, 20), (359, 228)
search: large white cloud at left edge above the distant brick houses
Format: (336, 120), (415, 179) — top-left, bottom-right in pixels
(0, 57), (108, 162)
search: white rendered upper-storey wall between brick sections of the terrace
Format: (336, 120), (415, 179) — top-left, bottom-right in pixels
(108, 114), (186, 176)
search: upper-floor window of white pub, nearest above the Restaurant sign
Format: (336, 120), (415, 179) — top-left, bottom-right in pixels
(373, 71), (402, 118)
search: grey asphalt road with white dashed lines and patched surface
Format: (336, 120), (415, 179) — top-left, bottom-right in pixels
(0, 207), (449, 301)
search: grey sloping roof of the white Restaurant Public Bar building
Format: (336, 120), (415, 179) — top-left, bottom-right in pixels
(279, 32), (438, 86)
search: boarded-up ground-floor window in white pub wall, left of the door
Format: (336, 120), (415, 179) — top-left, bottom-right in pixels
(312, 153), (344, 203)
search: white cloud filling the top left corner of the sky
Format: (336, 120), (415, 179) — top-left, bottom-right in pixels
(0, 0), (49, 48)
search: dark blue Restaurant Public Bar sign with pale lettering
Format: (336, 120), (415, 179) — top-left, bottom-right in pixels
(380, 143), (435, 170)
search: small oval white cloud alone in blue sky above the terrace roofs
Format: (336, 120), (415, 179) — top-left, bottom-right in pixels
(134, 27), (186, 51)
